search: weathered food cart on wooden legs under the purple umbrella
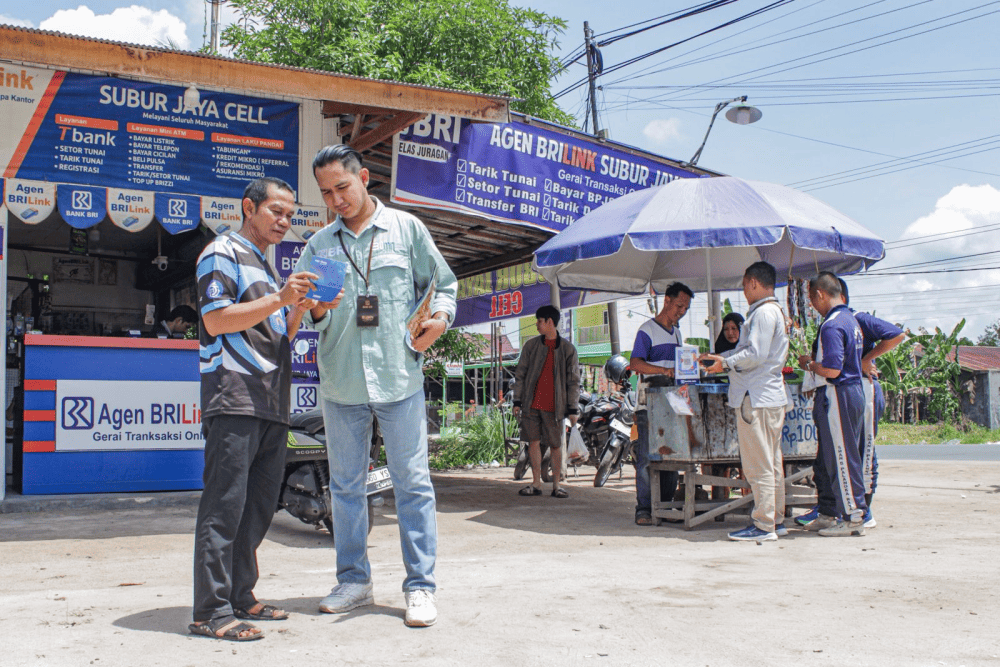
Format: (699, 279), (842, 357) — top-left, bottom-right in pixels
(646, 382), (817, 530)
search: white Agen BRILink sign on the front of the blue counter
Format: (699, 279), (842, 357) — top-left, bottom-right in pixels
(56, 380), (205, 452)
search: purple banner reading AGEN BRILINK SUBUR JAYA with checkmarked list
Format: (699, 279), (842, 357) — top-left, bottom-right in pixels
(392, 115), (697, 232)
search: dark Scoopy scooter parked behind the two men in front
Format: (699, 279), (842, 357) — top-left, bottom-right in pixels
(275, 410), (392, 536)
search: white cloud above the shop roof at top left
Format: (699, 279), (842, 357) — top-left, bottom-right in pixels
(39, 5), (190, 49)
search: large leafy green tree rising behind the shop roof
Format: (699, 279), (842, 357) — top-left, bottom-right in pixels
(222, 0), (573, 124)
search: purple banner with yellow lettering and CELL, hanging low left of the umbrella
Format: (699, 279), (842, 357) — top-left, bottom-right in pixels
(454, 262), (627, 327)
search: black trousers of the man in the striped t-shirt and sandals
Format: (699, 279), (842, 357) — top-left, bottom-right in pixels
(193, 415), (288, 622)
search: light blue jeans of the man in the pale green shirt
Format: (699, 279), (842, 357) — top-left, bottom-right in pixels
(323, 391), (437, 592)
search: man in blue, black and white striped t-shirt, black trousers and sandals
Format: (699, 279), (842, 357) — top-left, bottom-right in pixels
(188, 178), (317, 641)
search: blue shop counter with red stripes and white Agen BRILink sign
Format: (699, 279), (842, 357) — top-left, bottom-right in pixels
(21, 334), (204, 495)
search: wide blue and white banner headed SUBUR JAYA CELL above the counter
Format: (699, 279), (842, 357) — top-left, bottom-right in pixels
(0, 65), (299, 197)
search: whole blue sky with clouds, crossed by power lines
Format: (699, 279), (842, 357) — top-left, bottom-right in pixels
(0, 0), (1000, 347)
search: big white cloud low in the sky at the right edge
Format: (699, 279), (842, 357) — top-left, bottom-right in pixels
(847, 185), (1000, 341)
